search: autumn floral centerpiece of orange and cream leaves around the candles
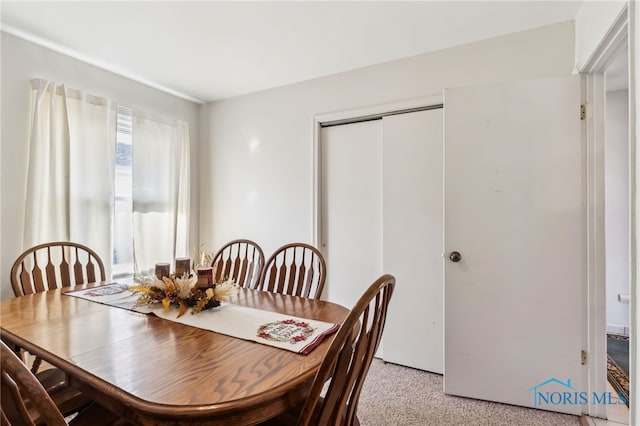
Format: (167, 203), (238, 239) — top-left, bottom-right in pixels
(129, 274), (238, 318)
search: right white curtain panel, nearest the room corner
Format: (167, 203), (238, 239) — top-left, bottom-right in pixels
(132, 111), (190, 275)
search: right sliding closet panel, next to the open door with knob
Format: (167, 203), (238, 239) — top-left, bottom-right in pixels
(382, 109), (444, 373)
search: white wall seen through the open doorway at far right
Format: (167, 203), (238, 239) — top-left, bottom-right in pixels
(605, 90), (630, 333)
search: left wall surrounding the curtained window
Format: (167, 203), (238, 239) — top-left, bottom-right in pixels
(0, 33), (200, 299)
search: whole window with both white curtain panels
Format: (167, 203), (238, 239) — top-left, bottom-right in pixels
(23, 79), (190, 278)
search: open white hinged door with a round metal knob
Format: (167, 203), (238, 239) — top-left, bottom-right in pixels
(444, 76), (588, 414)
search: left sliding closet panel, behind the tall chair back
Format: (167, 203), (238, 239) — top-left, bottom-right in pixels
(320, 120), (382, 308)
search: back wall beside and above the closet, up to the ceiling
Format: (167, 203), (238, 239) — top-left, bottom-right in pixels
(200, 22), (574, 255)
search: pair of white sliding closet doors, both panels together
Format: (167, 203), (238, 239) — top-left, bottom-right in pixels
(320, 109), (443, 373)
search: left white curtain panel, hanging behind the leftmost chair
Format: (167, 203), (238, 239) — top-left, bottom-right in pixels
(23, 79), (116, 276)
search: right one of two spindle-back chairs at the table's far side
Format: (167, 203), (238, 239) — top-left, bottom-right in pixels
(257, 243), (327, 299)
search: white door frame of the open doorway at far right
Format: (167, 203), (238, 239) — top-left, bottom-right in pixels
(580, 5), (636, 418)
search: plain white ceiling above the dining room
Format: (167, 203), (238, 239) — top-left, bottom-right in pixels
(1, 0), (582, 102)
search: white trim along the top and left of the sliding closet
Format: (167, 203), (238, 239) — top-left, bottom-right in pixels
(311, 93), (444, 246)
